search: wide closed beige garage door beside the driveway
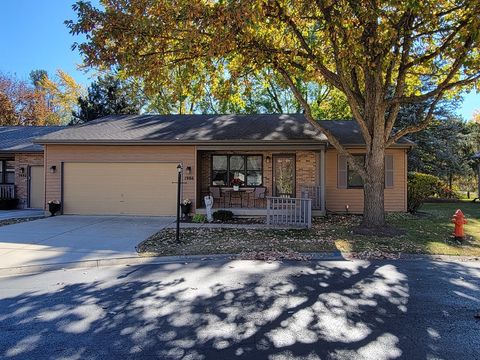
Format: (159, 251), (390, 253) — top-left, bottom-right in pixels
(63, 163), (178, 216)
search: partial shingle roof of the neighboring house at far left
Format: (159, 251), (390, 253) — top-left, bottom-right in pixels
(0, 126), (65, 153)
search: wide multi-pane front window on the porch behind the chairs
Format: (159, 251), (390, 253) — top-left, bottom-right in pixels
(212, 155), (263, 186)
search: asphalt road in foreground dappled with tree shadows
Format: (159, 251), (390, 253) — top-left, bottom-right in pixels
(0, 260), (480, 360)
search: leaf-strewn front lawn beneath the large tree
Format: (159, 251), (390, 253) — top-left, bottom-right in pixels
(138, 202), (480, 256)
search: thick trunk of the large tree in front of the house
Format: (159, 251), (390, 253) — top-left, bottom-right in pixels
(362, 144), (385, 228)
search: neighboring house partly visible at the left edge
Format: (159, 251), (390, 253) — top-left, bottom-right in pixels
(0, 126), (64, 208)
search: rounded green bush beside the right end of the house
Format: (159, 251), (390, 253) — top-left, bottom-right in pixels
(408, 172), (443, 214)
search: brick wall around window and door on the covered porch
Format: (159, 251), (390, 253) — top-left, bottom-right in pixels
(197, 151), (320, 207)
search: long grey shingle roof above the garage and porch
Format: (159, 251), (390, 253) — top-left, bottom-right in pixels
(37, 114), (414, 145)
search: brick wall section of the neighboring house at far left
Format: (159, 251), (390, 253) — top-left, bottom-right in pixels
(15, 153), (44, 208)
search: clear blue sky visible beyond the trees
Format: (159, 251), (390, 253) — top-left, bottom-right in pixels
(0, 0), (480, 120)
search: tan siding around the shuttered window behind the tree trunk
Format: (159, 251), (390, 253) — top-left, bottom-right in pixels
(325, 149), (407, 213)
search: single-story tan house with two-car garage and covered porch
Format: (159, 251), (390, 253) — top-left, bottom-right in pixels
(36, 115), (412, 215)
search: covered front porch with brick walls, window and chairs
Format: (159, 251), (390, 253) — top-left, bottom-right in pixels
(196, 143), (325, 216)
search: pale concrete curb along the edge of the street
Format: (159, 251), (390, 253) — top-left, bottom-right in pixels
(0, 251), (480, 278)
